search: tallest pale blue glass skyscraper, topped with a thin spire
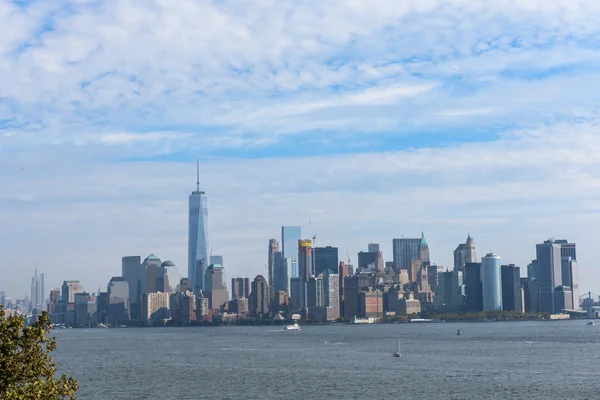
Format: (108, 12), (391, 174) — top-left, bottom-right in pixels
(188, 159), (209, 293)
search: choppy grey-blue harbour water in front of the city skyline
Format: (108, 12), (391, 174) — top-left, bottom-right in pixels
(56, 321), (600, 399)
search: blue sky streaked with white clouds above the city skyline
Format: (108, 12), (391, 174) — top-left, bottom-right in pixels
(0, 0), (600, 297)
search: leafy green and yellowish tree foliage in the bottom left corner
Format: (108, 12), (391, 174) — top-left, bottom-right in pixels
(0, 305), (78, 400)
